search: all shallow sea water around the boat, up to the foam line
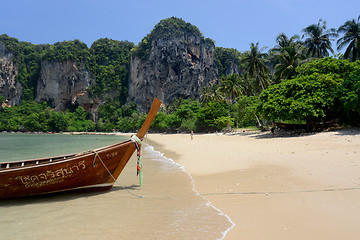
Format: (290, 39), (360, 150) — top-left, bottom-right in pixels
(0, 133), (233, 239)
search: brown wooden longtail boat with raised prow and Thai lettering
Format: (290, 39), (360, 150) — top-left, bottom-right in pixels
(0, 98), (161, 199)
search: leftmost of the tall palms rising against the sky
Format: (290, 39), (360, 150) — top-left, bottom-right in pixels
(242, 43), (270, 93)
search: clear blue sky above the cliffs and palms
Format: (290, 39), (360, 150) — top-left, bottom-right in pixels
(0, 0), (360, 52)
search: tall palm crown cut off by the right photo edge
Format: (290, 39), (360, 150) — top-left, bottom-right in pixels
(337, 15), (360, 62)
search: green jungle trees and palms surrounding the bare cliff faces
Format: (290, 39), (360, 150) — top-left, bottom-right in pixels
(0, 17), (360, 132)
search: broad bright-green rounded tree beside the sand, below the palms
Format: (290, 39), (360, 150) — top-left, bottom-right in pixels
(260, 73), (342, 124)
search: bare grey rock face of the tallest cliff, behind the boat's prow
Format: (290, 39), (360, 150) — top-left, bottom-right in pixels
(129, 33), (218, 111)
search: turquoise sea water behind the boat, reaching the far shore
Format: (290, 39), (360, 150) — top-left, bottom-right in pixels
(0, 133), (128, 162)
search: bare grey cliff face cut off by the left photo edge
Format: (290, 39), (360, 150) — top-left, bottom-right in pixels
(0, 42), (23, 105)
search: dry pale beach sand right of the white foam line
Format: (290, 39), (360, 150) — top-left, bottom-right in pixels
(145, 129), (360, 240)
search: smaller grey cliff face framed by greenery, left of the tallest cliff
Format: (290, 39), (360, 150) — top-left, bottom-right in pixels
(36, 60), (96, 111)
